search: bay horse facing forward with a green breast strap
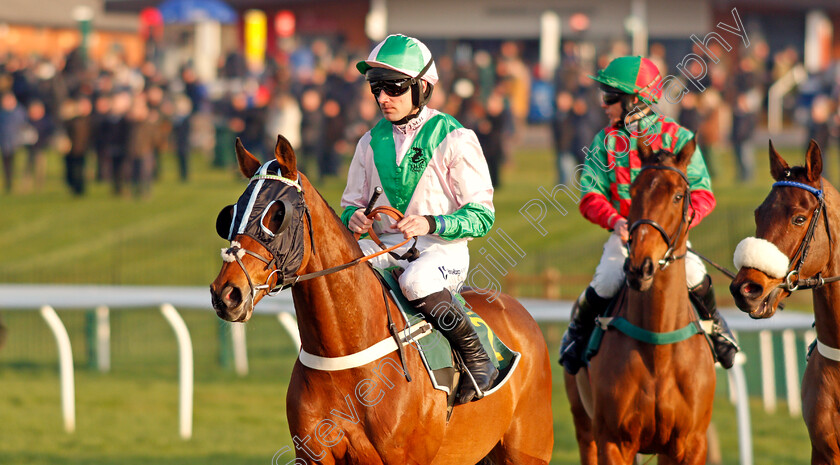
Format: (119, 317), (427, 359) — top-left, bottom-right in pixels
(565, 138), (715, 465)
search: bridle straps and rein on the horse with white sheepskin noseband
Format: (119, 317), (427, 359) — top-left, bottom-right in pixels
(772, 180), (840, 292)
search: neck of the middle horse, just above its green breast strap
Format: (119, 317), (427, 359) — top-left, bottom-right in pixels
(625, 252), (691, 332)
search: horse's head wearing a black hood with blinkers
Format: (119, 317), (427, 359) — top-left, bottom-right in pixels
(210, 136), (311, 321)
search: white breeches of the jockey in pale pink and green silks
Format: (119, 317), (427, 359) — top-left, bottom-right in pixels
(359, 234), (470, 300)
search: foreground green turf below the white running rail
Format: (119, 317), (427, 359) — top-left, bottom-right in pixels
(0, 309), (809, 465)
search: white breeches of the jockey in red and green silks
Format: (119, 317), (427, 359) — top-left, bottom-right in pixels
(589, 234), (706, 299)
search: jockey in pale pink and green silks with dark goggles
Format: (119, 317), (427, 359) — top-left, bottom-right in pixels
(341, 34), (498, 403)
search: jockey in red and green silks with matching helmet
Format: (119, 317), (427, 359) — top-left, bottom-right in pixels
(560, 56), (739, 374)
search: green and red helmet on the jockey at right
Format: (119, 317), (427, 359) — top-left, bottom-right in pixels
(589, 56), (662, 105)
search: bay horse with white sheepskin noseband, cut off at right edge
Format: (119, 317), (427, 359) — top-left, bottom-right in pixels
(729, 140), (840, 465)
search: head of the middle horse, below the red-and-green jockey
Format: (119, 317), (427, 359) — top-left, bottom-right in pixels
(624, 138), (695, 292)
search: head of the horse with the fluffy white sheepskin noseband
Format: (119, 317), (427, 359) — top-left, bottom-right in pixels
(729, 140), (831, 318)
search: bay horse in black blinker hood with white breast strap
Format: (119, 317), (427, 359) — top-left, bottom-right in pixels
(210, 136), (554, 465)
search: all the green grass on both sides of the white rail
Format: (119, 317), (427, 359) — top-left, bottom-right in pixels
(0, 138), (828, 465)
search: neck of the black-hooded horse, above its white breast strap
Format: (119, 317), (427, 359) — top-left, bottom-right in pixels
(292, 193), (394, 357)
